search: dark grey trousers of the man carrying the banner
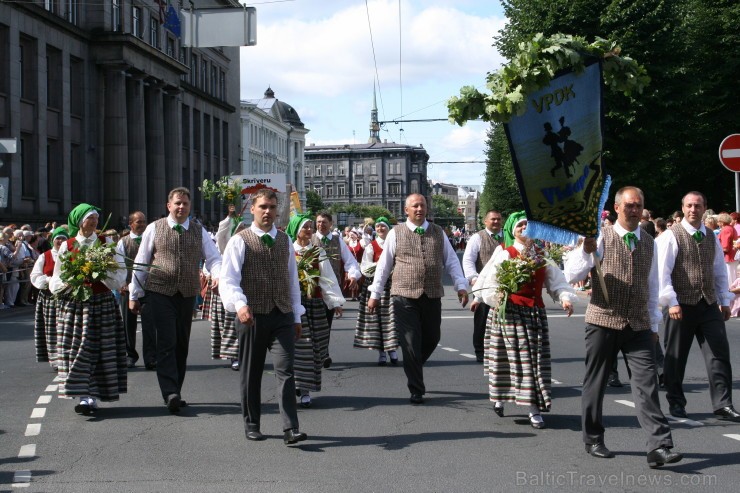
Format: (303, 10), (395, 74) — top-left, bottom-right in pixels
(581, 324), (673, 452)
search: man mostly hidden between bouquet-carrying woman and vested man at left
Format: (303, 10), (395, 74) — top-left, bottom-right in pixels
(116, 211), (157, 370)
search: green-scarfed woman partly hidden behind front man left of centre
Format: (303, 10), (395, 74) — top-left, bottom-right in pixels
(285, 213), (345, 407)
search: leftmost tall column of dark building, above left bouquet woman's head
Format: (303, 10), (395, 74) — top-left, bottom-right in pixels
(103, 68), (129, 228)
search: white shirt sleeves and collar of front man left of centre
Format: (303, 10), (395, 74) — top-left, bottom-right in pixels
(218, 223), (306, 324)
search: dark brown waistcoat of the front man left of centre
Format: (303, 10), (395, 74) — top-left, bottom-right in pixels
(238, 229), (293, 315)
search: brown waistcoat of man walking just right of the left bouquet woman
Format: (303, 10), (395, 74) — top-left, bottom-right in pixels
(146, 217), (203, 298)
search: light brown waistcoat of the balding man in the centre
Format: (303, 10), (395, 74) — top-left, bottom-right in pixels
(391, 223), (448, 299)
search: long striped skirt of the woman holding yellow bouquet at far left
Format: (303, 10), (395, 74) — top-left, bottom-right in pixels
(57, 292), (127, 401)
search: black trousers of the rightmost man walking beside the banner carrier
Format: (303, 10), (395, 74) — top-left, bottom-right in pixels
(663, 299), (732, 411)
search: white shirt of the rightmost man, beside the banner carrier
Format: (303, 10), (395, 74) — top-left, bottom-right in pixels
(655, 218), (735, 308)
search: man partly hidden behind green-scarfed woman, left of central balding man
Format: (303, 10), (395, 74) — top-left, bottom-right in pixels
(311, 212), (362, 368)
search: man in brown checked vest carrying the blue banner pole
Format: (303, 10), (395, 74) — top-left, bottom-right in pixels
(565, 187), (683, 468)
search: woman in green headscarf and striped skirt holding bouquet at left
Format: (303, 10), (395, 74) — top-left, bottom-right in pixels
(49, 203), (127, 415)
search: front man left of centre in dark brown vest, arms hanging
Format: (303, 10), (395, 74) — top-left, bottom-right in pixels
(221, 189), (306, 445)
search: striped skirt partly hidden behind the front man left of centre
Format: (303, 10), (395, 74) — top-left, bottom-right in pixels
(294, 296), (329, 392)
